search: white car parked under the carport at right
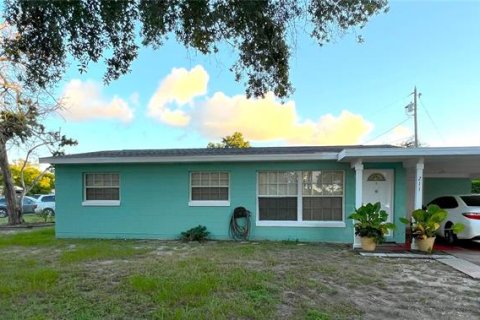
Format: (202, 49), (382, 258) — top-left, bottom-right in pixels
(429, 194), (480, 243)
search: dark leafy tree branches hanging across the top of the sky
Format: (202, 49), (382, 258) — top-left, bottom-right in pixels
(5, 0), (387, 98)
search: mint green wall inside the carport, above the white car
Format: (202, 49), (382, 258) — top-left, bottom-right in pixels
(423, 178), (472, 204)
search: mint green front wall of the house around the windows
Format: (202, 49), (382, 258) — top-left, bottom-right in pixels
(55, 161), (405, 243)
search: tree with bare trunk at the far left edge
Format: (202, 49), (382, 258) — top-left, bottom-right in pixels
(0, 24), (76, 225)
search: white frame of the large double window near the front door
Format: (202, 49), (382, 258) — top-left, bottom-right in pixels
(255, 169), (346, 228)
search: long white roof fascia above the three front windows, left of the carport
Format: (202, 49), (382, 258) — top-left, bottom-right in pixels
(40, 152), (338, 164)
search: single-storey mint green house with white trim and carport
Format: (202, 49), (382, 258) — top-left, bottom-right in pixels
(41, 146), (480, 243)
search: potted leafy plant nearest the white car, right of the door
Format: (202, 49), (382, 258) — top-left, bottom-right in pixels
(400, 204), (465, 252)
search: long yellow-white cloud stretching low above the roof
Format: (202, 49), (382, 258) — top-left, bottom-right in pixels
(192, 92), (372, 145)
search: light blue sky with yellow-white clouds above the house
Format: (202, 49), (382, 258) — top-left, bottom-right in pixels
(14, 0), (480, 160)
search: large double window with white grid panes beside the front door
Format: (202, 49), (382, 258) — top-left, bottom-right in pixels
(257, 170), (345, 226)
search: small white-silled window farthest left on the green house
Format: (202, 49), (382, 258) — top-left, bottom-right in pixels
(84, 173), (120, 205)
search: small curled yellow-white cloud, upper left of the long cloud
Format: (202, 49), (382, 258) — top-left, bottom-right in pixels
(147, 65), (209, 126)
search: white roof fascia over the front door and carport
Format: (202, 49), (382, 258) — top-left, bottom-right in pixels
(338, 147), (480, 161)
